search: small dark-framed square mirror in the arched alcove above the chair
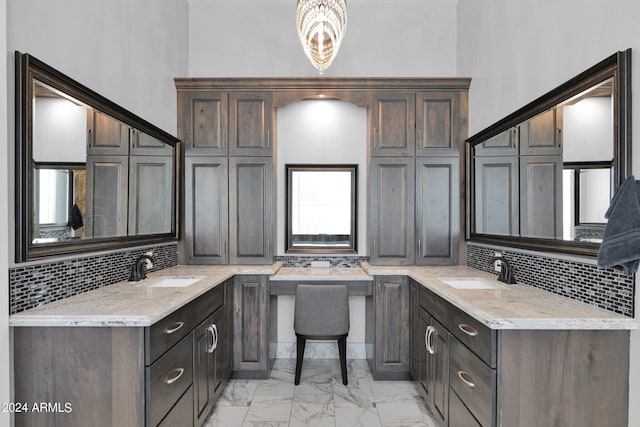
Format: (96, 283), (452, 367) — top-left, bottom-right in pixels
(285, 165), (358, 252)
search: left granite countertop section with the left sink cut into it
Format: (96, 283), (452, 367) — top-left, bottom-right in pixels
(9, 263), (280, 327)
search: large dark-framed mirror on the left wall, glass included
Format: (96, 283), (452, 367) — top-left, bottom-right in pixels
(15, 52), (180, 262)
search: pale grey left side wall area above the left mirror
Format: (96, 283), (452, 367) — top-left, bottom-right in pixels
(7, 0), (188, 135)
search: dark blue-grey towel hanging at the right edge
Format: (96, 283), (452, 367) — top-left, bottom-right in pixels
(598, 176), (640, 274)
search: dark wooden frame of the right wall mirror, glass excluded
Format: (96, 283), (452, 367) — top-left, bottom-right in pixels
(466, 49), (632, 257)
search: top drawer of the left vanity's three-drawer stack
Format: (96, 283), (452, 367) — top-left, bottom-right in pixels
(144, 303), (196, 366)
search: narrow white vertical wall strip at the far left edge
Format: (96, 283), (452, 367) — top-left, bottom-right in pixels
(0, 0), (13, 426)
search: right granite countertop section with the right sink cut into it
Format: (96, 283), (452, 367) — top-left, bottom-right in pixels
(363, 263), (638, 329)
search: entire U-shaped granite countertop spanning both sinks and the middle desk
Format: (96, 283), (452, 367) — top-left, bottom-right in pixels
(9, 263), (638, 329)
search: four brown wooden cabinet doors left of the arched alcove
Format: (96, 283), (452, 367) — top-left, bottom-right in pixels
(178, 90), (275, 264)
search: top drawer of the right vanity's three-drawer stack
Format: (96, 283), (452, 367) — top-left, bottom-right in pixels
(447, 305), (496, 368)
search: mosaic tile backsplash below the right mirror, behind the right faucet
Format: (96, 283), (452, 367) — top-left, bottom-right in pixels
(467, 244), (635, 317)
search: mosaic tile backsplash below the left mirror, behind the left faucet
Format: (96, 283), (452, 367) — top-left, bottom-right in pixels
(9, 244), (178, 314)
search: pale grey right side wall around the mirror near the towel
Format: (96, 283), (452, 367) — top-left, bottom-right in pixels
(457, 0), (640, 426)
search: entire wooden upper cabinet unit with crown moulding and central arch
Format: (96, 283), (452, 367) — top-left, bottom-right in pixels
(176, 78), (469, 265)
